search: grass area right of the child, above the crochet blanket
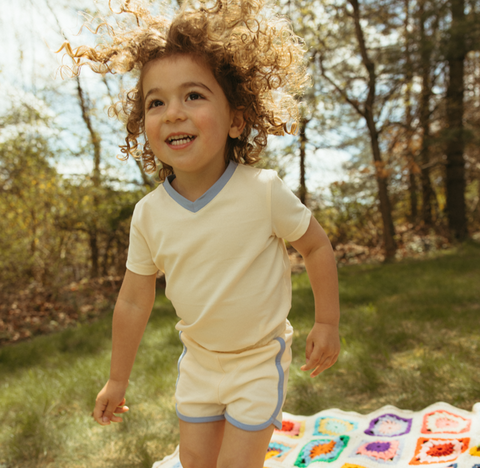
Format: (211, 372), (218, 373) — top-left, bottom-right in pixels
(286, 243), (480, 414)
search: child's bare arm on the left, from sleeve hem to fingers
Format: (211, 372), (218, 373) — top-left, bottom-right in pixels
(93, 270), (156, 425)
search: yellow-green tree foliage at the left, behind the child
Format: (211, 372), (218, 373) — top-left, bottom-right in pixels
(0, 85), (140, 290)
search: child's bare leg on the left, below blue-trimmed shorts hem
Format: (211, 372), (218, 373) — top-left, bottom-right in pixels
(179, 419), (225, 468)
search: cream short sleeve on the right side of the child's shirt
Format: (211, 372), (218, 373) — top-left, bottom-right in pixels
(271, 174), (312, 242)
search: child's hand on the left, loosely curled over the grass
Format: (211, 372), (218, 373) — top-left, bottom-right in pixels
(92, 380), (129, 426)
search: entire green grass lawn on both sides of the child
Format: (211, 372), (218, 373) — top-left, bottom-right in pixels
(0, 243), (480, 468)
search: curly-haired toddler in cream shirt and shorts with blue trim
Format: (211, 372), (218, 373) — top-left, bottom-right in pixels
(58, 0), (340, 468)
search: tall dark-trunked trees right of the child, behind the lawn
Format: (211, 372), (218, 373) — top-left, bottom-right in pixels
(288, 0), (479, 259)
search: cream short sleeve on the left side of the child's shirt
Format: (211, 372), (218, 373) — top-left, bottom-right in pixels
(127, 205), (158, 275)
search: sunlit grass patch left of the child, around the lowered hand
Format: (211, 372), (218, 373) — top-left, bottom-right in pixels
(0, 293), (182, 468)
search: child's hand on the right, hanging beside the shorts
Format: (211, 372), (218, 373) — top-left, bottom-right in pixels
(300, 322), (340, 377)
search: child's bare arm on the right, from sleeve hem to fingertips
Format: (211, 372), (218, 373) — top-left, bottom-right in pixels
(291, 216), (340, 377)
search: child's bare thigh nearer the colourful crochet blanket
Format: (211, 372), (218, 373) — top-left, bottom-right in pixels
(216, 421), (274, 468)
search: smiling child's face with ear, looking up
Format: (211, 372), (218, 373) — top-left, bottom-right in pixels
(143, 55), (243, 177)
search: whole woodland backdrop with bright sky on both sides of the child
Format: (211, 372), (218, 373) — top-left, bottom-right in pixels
(0, 0), (480, 345)
